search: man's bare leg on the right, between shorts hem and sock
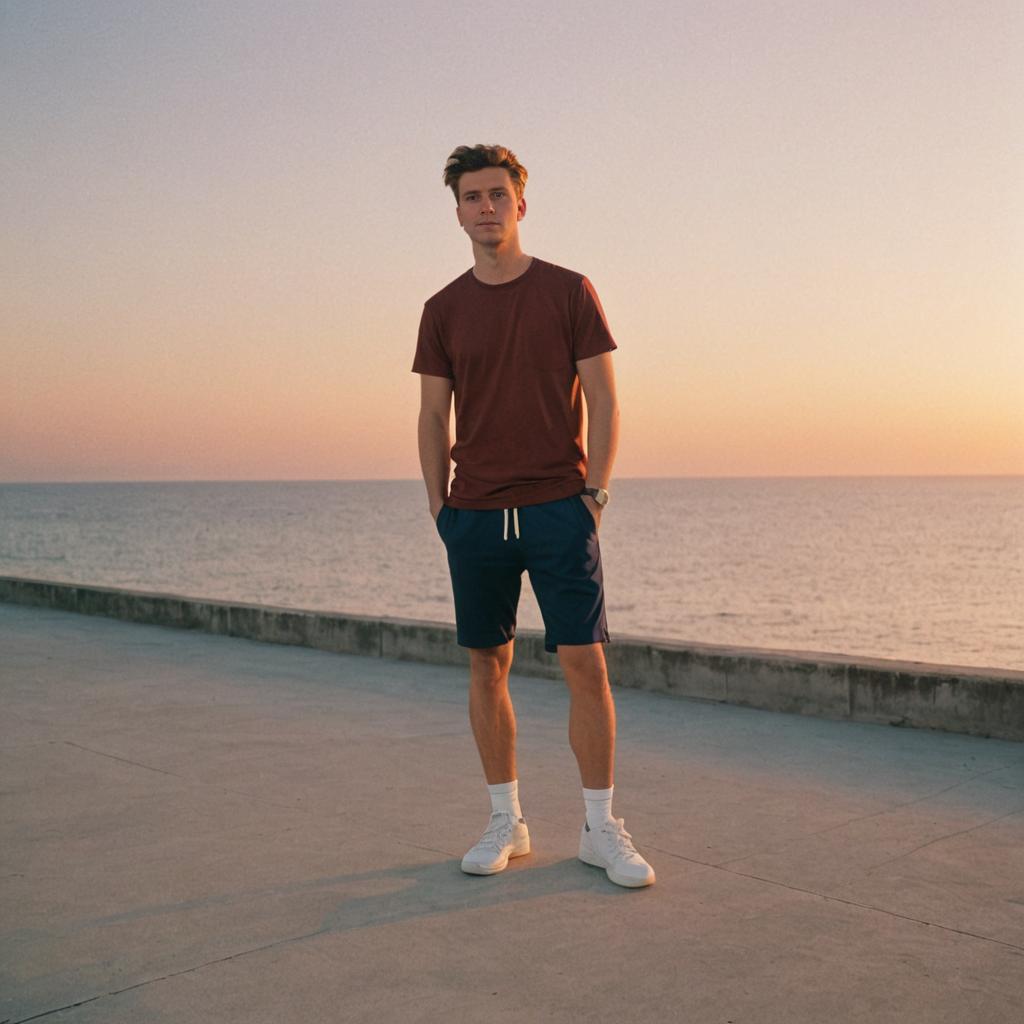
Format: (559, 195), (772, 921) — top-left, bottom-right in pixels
(558, 643), (615, 790)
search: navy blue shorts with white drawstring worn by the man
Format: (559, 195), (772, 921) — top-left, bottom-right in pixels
(436, 495), (610, 654)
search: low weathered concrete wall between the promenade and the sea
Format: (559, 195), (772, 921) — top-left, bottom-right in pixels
(0, 577), (1024, 740)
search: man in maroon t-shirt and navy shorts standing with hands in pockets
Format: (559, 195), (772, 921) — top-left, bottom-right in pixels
(413, 145), (654, 887)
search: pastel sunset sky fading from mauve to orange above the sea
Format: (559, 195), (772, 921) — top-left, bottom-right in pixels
(0, 0), (1024, 481)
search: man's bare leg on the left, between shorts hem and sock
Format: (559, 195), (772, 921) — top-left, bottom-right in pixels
(469, 640), (516, 785)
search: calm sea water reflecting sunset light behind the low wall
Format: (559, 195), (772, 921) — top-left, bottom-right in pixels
(0, 477), (1024, 669)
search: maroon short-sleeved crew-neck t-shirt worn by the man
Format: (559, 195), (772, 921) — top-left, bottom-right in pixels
(413, 256), (617, 509)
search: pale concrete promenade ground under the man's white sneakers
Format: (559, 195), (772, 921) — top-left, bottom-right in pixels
(6, 604), (1024, 1024)
